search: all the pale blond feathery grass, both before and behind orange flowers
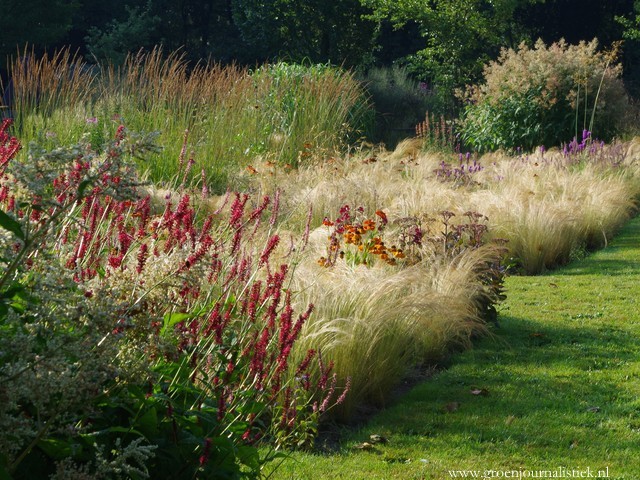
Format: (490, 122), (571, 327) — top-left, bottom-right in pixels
(254, 140), (640, 418)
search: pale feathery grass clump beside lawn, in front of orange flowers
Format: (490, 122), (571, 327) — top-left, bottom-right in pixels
(294, 238), (496, 419)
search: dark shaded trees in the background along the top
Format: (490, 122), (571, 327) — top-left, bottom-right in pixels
(0, 0), (640, 100)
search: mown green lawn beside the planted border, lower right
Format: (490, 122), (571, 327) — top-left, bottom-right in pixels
(272, 218), (640, 480)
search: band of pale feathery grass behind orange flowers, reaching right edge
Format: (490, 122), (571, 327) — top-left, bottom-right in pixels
(278, 140), (640, 273)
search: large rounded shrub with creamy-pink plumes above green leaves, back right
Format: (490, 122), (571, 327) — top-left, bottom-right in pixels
(461, 40), (631, 151)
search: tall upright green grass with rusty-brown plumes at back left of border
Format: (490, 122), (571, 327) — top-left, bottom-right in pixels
(5, 48), (373, 191)
